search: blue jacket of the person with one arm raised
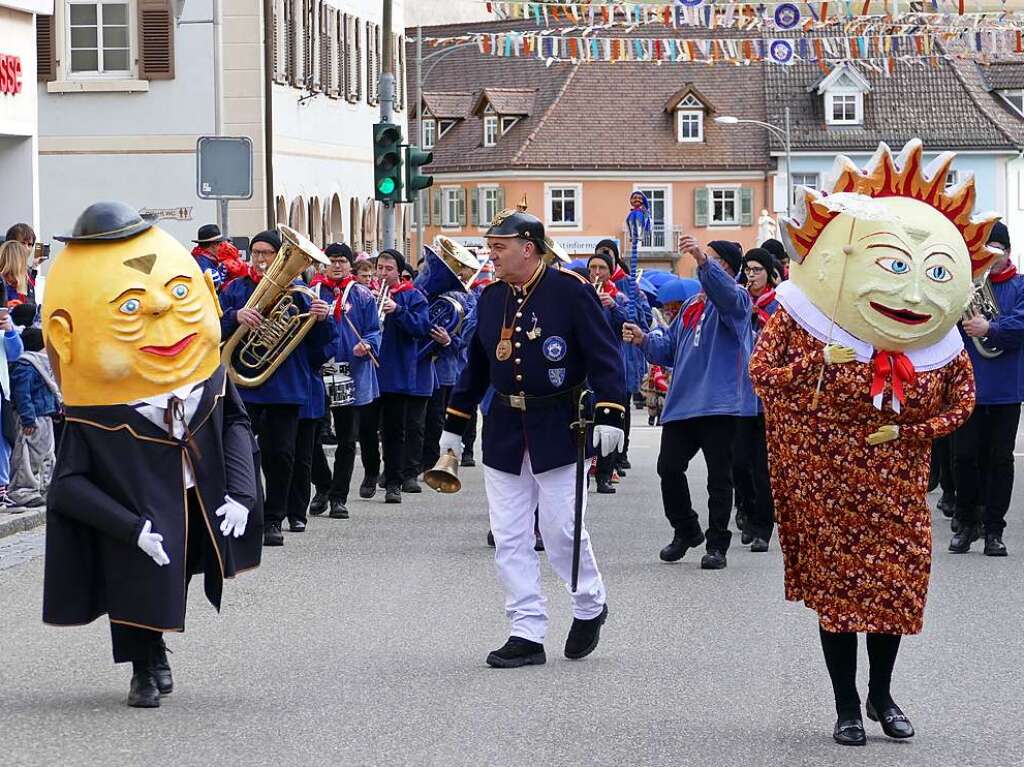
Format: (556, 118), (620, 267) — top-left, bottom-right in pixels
(643, 260), (758, 423)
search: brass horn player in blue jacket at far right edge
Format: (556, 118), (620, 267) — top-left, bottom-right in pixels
(949, 221), (1024, 557)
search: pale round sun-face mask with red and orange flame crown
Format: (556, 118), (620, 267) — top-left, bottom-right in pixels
(782, 139), (997, 351)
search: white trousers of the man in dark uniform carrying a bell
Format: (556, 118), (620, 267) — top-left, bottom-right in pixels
(483, 453), (605, 642)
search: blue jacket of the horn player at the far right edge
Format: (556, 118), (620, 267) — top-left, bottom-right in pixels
(961, 275), (1024, 404)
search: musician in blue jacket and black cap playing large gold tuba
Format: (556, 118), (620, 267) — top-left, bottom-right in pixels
(220, 229), (332, 546)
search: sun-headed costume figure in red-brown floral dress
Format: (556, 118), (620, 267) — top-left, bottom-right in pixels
(750, 139), (996, 734)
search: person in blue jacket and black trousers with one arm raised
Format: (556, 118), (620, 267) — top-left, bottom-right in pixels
(623, 236), (757, 569)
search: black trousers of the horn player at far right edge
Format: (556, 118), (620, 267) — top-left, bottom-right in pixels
(953, 403), (1021, 536)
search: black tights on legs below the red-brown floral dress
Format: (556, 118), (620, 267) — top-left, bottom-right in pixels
(818, 626), (902, 719)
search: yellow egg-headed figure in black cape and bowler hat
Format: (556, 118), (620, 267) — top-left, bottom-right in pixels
(43, 202), (263, 708)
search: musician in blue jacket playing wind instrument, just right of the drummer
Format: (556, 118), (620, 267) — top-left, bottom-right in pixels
(374, 250), (433, 504)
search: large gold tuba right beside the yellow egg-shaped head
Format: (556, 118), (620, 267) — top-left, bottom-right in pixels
(221, 224), (330, 389)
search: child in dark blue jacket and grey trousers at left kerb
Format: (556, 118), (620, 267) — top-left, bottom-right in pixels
(8, 328), (60, 508)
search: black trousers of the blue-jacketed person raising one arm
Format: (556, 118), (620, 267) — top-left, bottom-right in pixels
(657, 416), (736, 552)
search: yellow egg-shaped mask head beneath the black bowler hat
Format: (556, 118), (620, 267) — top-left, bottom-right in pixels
(43, 226), (220, 406)
